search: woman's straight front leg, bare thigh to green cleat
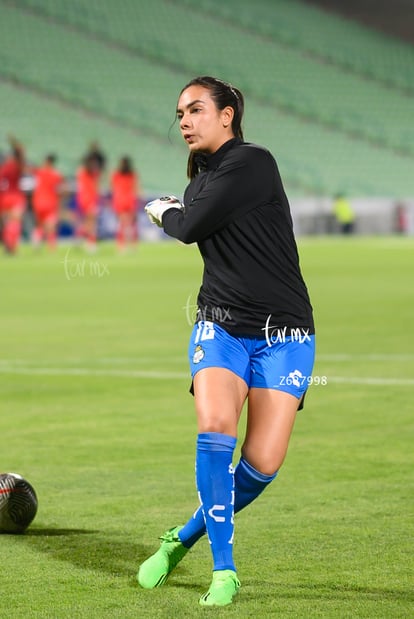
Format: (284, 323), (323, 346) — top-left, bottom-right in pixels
(194, 367), (247, 606)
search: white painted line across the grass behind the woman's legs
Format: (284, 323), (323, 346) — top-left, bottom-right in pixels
(0, 365), (414, 387)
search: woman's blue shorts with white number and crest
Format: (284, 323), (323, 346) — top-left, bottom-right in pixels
(188, 320), (315, 399)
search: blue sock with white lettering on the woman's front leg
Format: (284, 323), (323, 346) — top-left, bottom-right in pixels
(192, 432), (236, 570)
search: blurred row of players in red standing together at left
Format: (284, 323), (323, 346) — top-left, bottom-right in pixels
(0, 136), (141, 254)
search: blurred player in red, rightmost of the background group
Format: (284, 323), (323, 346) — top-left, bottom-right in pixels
(111, 157), (139, 251)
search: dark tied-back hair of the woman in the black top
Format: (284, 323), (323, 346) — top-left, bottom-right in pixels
(180, 75), (244, 178)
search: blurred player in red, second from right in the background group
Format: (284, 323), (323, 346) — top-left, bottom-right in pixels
(76, 155), (101, 250)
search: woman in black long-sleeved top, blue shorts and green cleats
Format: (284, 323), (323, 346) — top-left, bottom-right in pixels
(137, 77), (314, 606)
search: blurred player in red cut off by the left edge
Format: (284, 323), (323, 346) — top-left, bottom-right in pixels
(0, 137), (26, 254)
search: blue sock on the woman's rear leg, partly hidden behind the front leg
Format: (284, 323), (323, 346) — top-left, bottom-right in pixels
(178, 456), (278, 548)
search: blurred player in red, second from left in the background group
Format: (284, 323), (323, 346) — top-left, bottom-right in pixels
(32, 155), (64, 249)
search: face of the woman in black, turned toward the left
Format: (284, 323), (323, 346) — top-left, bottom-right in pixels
(177, 86), (234, 154)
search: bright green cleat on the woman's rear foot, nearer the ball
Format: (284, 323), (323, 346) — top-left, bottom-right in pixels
(137, 527), (190, 589)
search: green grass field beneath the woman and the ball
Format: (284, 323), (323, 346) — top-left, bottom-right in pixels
(0, 237), (414, 619)
